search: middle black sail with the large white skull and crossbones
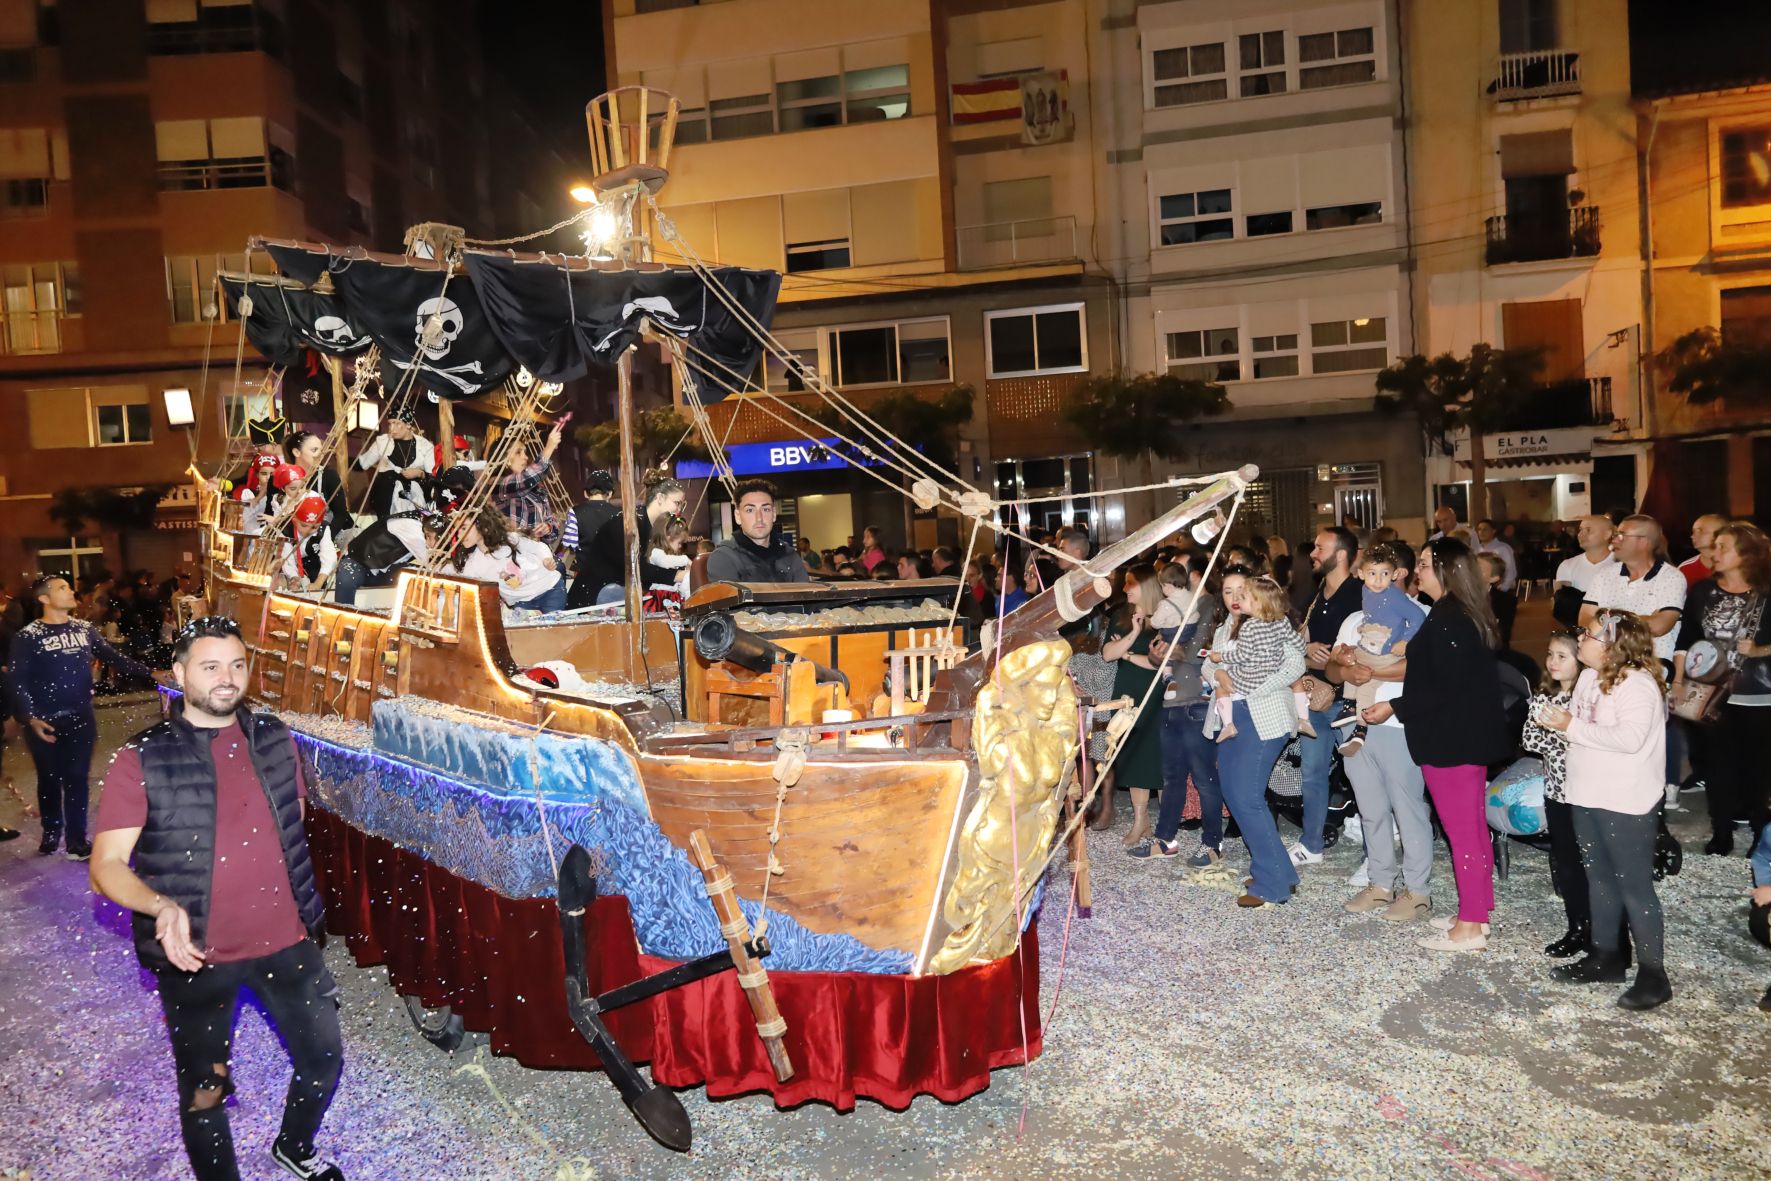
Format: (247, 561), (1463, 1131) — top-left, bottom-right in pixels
(266, 246), (515, 398)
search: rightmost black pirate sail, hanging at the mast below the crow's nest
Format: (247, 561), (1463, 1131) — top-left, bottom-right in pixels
(464, 251), (781, 400)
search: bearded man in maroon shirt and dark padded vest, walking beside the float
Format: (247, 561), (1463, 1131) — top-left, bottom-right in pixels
(92, 616), (344, 1181)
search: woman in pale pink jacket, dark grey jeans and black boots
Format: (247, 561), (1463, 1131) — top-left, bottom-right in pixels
(1539, 611), (1672, 1009)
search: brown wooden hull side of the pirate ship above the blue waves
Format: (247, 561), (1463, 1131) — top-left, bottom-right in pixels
(213, 563), (976, 970)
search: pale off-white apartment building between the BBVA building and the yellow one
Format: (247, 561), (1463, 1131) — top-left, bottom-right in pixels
(1098, 0), (1424, 540)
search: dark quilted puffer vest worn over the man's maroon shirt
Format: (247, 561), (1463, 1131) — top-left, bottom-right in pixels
(131, 701), (326, 970)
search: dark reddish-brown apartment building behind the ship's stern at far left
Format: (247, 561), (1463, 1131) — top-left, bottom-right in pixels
(0, 0), (565, 574)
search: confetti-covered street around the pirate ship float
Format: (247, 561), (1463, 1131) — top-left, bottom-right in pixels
(0, 686), (1771, 1181)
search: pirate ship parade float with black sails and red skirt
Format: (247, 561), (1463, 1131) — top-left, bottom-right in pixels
(200, 89), (1254, 1149)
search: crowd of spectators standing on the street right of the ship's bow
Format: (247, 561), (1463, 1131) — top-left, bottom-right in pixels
(1034, 510), (1771, 1009)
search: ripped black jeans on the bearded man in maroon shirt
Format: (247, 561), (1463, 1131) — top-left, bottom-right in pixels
(158, 938), (344, 1181)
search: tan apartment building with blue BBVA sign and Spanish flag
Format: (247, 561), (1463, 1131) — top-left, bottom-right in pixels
(609, 0), (1112, 547)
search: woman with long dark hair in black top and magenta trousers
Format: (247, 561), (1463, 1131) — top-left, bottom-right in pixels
(1364, 536), (1509, 951)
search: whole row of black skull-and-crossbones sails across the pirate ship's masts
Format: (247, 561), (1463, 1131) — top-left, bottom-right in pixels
(221, 239), (781, 402)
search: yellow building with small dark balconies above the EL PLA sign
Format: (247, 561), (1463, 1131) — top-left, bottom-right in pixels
(1404, 0), (1649, 521)
